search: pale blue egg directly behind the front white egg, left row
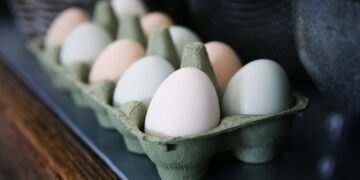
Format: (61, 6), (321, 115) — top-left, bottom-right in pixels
(113, 56), (174, 107)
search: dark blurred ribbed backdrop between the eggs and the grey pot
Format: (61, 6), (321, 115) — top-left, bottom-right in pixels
(188, 0), (308, 80)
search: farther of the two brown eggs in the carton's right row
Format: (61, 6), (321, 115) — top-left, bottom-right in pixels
(141, 12), (174, 37)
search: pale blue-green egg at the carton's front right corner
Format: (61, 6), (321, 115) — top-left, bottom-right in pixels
(222, 59), (292, 115)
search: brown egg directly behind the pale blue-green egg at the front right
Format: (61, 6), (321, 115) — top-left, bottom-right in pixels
(205, 41), (241, 94)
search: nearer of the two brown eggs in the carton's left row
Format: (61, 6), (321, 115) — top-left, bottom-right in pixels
(89, 39), (145, 83)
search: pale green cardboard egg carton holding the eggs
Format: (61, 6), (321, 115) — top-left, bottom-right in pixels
(29, 4), (308, 180)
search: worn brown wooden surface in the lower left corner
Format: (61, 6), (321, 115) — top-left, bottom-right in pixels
(0, 61), (116, 180)
